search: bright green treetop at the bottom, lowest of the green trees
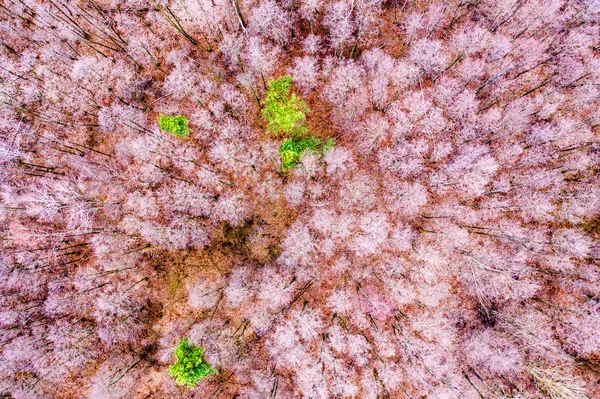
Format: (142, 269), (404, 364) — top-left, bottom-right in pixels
(169, 338), (218, 389)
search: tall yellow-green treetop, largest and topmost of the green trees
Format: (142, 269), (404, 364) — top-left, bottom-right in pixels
(262, 76), (309, 134)
